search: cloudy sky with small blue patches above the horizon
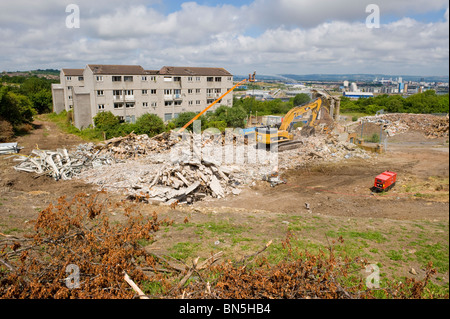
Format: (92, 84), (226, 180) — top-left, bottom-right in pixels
(0, 0), (449, 76)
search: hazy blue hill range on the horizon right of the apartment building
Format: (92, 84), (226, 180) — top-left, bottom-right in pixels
(234, 74), (449, 82)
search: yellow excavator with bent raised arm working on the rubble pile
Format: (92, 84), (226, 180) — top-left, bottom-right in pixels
(255, 93), (330, 151)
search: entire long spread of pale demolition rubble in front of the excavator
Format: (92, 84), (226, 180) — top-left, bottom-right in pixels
(15, 133), (369, 204)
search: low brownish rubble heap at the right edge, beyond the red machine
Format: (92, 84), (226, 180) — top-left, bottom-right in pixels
(359, 113), (449, 138)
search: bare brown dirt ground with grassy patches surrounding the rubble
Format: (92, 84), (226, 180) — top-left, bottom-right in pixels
(0, 120), (449, 285)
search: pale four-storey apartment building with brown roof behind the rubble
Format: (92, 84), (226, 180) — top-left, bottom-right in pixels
(52, 64), (233, 129)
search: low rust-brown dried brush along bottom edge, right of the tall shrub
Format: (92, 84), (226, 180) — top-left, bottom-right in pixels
(166, 233), (442, 299)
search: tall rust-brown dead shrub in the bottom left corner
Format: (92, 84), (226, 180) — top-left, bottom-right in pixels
(0, 193), (172, 298)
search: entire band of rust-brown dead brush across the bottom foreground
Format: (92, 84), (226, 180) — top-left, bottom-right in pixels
(0, 192), (442, 299)
